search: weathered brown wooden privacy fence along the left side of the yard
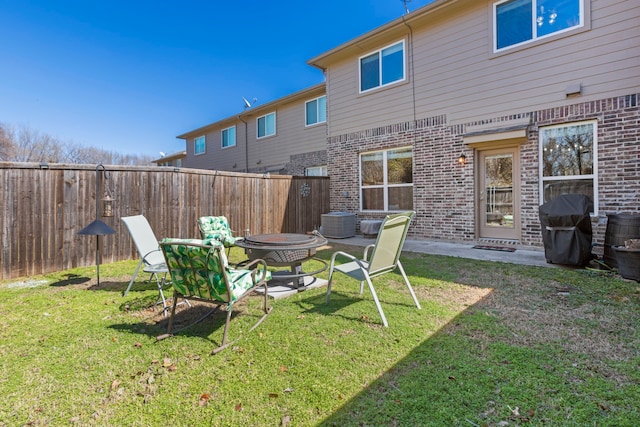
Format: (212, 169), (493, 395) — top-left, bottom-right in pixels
(0, 162), (329, 279)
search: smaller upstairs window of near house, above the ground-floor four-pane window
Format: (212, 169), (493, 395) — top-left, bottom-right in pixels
(360, 40), (405, 92)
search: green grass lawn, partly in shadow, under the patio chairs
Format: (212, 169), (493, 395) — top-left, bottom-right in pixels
(0, 245), (640, 426)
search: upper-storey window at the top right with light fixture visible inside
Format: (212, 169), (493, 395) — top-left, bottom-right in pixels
(493, 0), (584, 51)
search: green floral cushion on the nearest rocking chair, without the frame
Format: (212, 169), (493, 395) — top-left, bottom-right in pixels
(160, 239), (271, 303)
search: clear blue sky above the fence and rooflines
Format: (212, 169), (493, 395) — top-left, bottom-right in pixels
(0, 0), (432, 157)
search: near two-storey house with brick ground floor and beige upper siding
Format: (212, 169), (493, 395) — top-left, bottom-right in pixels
(181, 0), (640, 246)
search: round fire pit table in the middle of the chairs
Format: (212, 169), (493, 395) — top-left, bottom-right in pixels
(236, 232), (327, 290)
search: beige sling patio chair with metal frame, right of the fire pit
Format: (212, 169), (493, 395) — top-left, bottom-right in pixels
(327, 211), (422, 327)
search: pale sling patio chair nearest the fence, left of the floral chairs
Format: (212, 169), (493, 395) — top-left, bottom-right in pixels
(121, 215), (169, 306)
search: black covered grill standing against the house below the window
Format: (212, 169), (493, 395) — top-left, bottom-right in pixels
(539, 194), (593, 266)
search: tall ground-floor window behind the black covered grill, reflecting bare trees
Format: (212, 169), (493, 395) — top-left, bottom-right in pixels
(540, 121), (598, 215)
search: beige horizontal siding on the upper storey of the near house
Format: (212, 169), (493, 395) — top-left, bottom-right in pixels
(327, 0), (640, 136)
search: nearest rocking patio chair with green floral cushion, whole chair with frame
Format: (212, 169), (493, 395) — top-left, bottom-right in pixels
(158, 238), (271, 354)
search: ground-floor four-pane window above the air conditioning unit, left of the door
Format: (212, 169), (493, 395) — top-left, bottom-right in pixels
(360, 147), (413, 211)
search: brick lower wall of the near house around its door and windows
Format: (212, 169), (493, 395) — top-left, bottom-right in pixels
(327, 94), (640, 247)
